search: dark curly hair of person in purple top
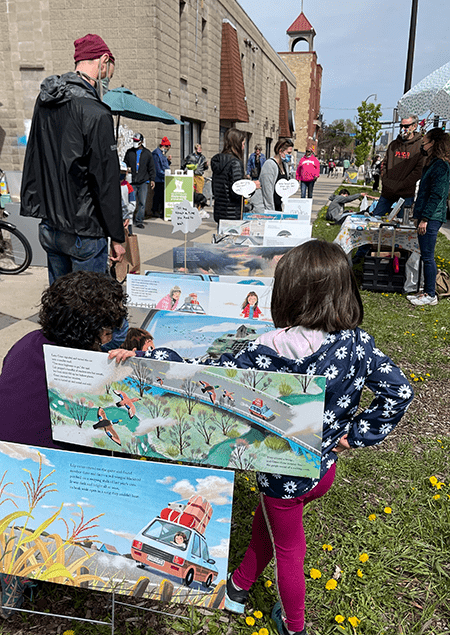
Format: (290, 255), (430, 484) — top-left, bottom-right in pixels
(39, 271), (127, 350)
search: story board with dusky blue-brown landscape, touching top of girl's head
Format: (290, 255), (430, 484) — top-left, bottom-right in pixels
(173, 243), (291, 277)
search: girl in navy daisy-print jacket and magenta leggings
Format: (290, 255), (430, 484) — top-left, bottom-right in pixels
(110, 240), (413, 635)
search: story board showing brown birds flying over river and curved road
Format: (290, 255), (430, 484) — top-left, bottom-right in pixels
(44, 346), (326, 478)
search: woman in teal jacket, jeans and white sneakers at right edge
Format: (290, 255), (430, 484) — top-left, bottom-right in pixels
(407, 128), (450, 306)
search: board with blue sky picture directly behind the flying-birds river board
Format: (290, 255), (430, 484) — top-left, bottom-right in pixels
(142, 310), (274, 359)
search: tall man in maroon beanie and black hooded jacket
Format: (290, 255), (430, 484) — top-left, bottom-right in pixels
(20, 34), (125, 284)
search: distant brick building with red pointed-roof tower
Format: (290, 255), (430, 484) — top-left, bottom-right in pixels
(279, 11), (322, 153)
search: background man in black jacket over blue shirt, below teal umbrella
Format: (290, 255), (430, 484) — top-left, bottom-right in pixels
(124, 132), (156, 229)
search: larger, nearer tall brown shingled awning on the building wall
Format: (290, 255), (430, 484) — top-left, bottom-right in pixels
(220, 22), (249, 122)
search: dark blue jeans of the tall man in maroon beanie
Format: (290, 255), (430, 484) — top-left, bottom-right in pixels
(39, 221), (108, 284)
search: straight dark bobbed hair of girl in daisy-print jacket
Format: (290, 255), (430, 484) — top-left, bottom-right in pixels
(271, 240), (364, 333)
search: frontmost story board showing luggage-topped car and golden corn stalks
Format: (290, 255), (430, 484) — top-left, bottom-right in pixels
(0, 442), (234, 608)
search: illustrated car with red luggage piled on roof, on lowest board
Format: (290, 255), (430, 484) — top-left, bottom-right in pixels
(131, 495), (218, 588)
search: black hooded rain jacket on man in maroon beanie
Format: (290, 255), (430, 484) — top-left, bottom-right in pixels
(20, 72), (125, 242)
